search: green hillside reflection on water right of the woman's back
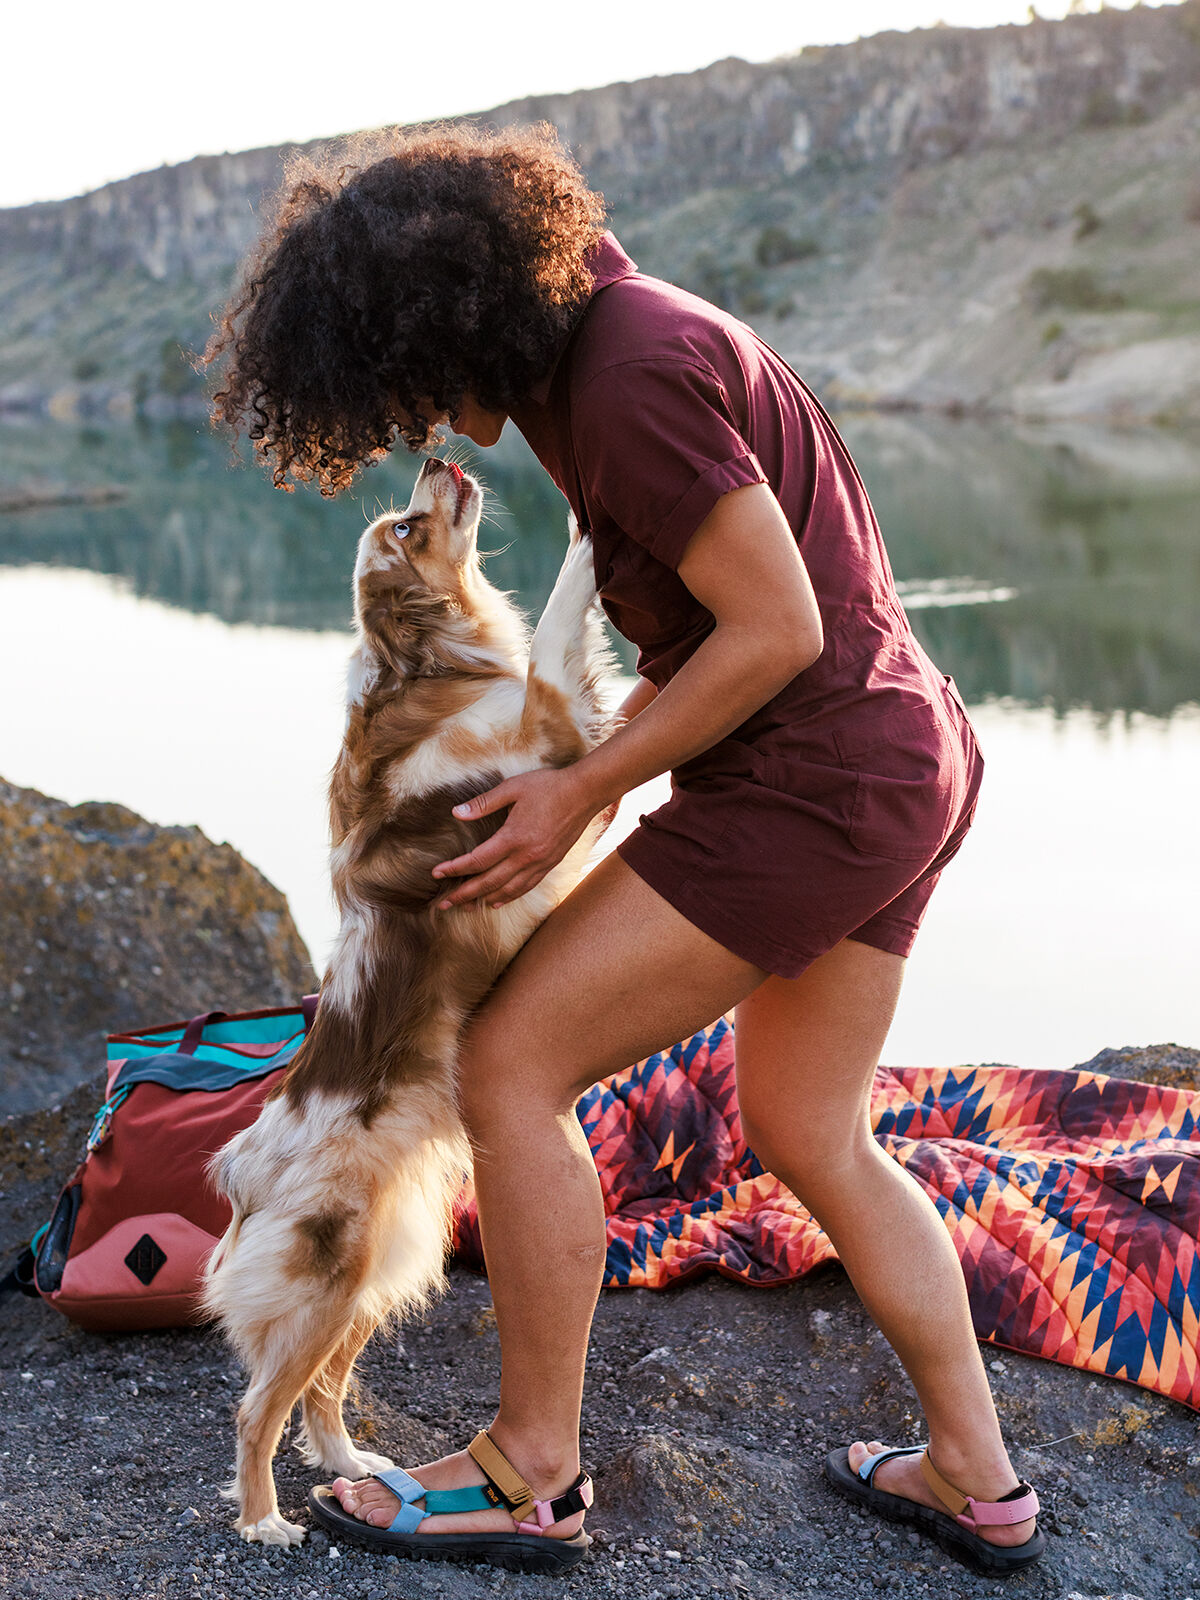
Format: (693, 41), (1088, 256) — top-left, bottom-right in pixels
(845, 418), (1200, 717)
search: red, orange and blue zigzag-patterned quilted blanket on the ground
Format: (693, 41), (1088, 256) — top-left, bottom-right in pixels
(458, 1021), (1200, 1410)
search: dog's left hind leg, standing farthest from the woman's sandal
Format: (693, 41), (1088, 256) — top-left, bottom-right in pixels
(227, 1301), (354, 1544)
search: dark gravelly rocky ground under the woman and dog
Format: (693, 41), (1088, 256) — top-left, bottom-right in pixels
(0, 1048), (1200, 1600)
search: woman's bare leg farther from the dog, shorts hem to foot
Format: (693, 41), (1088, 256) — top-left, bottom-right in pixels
(738, 939), (1034, 1546)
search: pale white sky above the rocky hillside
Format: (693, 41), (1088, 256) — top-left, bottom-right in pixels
(0, 0), (1171, 206)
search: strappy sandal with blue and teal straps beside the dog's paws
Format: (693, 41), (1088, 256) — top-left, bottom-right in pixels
(309, 1429), (592, 1573)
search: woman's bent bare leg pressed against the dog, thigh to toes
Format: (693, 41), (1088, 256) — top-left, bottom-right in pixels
(334, 856), (765, 1536)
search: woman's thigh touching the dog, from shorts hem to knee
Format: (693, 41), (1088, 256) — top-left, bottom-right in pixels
(461, 856), (766, 1122)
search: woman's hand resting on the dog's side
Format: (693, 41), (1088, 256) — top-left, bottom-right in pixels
(434, 766), (603, 910)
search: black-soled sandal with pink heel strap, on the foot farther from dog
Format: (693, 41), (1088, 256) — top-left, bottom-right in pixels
(826, 1445), (1046, 1578)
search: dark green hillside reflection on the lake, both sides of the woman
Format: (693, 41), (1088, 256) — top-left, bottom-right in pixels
(0, 416), (1200, 715)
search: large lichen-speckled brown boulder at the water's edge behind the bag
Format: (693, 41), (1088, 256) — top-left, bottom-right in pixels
(0, 779), (317, 1112)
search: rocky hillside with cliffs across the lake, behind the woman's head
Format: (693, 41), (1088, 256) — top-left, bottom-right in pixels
(0, 0), (1200, 419)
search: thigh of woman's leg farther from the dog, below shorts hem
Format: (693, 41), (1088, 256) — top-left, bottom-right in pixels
(736, 939), (904, 1198)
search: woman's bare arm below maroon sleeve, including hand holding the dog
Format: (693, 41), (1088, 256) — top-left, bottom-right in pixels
(434, 483), (822, 906)
